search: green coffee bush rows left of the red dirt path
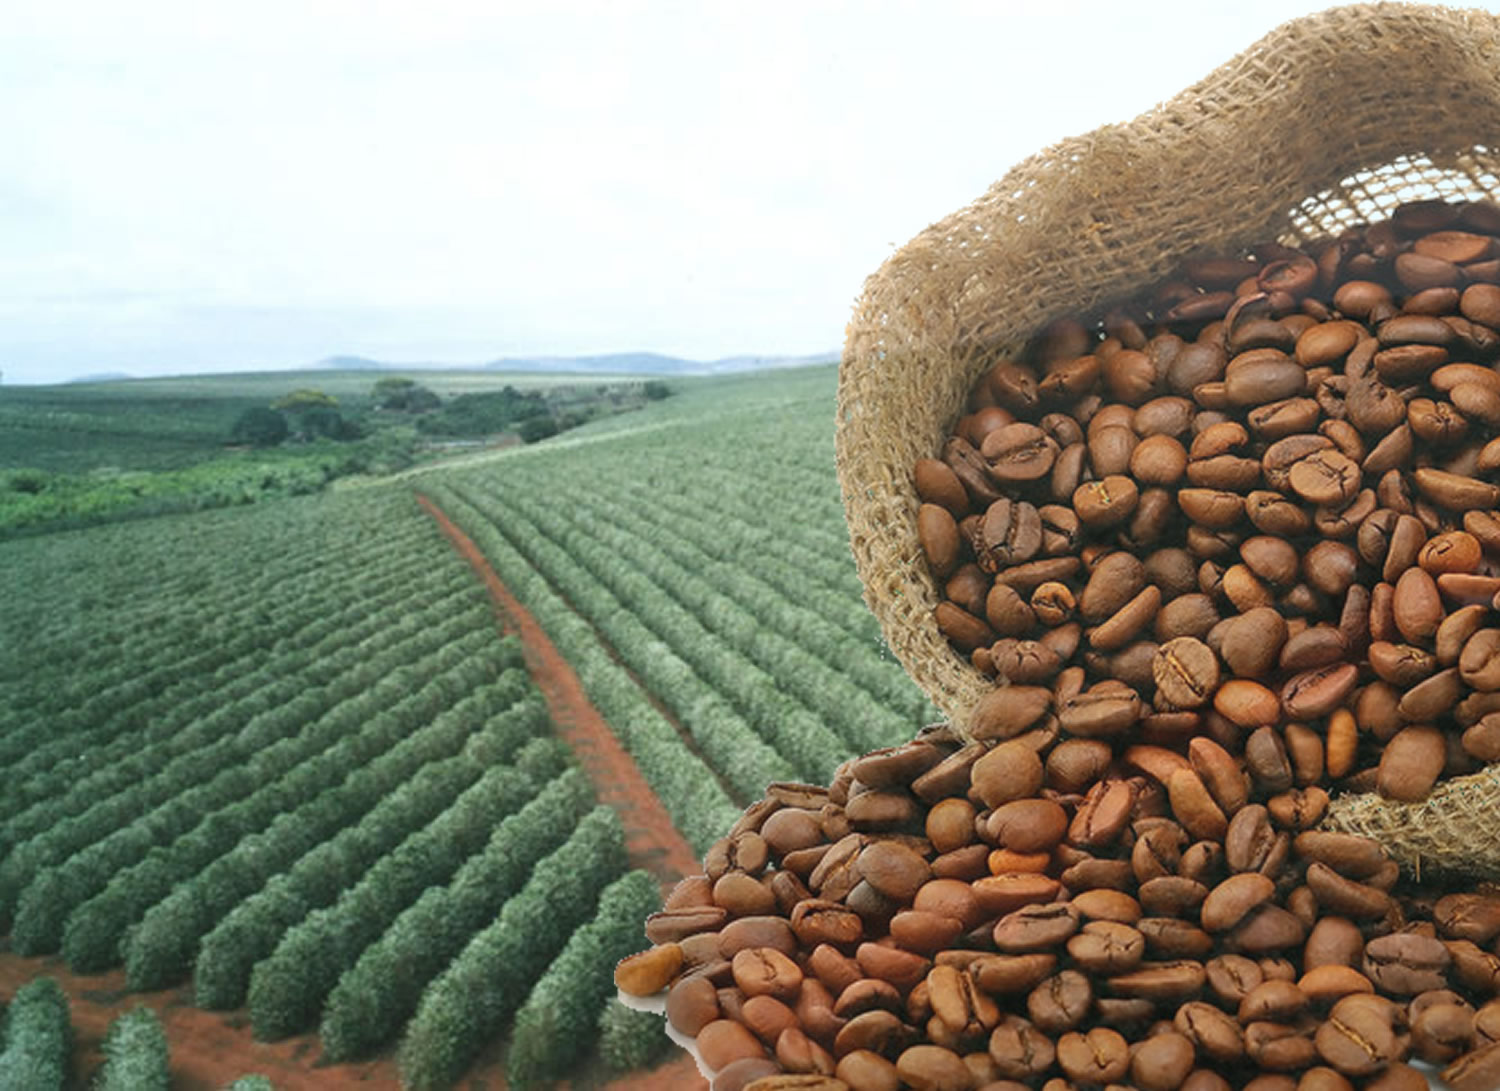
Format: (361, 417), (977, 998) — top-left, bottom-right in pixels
(0, 489), (663, 1088)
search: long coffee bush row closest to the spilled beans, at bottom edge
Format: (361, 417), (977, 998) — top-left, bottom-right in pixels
(506, 870), (665, 1088)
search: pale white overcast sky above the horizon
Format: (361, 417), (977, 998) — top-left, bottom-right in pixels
(0, 0), (1500, 383)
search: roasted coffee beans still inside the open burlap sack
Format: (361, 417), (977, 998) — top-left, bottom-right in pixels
(914, 201), (1500, 806)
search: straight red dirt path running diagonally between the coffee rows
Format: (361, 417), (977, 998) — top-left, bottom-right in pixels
(417, 494), (701, 885)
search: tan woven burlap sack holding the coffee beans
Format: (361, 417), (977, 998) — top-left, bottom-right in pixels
(836, 3), (1500, 878)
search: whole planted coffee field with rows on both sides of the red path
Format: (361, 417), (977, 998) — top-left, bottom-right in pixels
(0, 366), (935, 1086)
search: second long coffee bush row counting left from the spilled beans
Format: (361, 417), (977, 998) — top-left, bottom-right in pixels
(401, 807), (626, 1089)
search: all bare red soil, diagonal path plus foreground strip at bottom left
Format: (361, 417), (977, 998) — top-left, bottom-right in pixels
(0, 495), (708, 1091)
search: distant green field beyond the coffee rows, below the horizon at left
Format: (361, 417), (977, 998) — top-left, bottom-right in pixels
(0, 371), (669, 539)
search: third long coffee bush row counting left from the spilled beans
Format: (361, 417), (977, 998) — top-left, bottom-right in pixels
(318, 768), (594, 1061)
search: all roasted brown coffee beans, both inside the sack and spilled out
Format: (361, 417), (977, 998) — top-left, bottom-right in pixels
(615, 201), (1500, 1091)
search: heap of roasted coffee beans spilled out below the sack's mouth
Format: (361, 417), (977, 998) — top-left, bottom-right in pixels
(615, 726), (1500, 1091)
